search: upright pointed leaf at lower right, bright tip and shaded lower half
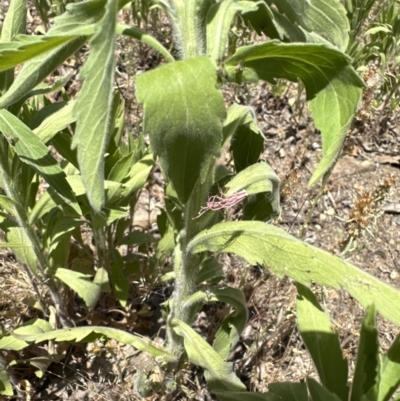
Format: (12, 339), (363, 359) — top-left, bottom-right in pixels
(296, 284), (349, 401)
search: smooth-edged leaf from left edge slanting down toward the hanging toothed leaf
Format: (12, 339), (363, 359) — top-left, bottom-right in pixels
(0, 110), (79, 213)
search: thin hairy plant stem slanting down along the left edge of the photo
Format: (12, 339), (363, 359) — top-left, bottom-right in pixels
(0, 137), (71, 327)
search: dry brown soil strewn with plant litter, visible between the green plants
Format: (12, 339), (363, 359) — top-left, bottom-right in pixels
(0, 3), (400, 401)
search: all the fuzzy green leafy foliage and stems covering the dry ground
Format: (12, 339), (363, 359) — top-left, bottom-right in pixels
(0, 0), (400, 401)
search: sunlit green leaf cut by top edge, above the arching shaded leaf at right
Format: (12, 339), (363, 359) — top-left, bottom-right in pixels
(273, 0), (350, 52)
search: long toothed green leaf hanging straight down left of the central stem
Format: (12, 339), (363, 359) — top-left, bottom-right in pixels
(73, 0), (118, 212)
